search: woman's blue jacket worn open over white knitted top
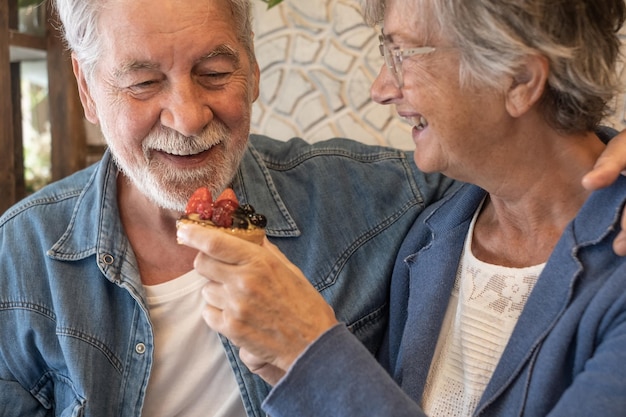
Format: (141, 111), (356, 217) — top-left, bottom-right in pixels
(265, 177), (626, 417)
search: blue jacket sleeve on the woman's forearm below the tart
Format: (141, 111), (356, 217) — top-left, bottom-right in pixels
(263, 325), (424, 417)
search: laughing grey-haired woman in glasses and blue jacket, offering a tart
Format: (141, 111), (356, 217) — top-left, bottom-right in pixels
(180, 0), (626, 417)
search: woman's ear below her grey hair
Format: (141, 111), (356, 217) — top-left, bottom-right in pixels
(506, 55), (550, 117)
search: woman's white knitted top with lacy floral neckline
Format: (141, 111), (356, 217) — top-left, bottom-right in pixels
(422, 208), (545, 417)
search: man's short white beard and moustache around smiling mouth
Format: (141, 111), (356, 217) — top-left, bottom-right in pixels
(102, 122), (247, 212)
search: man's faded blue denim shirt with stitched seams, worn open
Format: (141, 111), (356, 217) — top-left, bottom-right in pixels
(0, 135), (453, 417)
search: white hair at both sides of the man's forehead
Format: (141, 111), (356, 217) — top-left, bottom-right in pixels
(53, 0), (256, 84)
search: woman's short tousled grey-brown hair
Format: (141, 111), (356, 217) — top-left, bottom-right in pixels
(363, 0), (626, 132)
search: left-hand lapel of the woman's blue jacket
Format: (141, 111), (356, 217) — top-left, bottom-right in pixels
(391, 186), (485, 397)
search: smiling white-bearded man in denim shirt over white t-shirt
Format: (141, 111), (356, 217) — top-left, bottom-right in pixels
(0, 0), (619, 417)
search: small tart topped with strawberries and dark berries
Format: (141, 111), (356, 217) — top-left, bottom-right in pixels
(176, 187), (267, 245)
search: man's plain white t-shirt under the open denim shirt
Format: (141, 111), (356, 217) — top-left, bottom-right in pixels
(142, 271), (246, 417)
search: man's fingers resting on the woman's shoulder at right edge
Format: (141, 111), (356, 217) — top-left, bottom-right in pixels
(582, 130), (626, 256)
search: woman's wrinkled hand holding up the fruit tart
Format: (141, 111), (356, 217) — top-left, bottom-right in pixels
(177, 225), (337, 383)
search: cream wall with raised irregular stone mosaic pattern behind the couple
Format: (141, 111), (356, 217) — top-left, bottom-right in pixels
(252, 0), (626, 149)
